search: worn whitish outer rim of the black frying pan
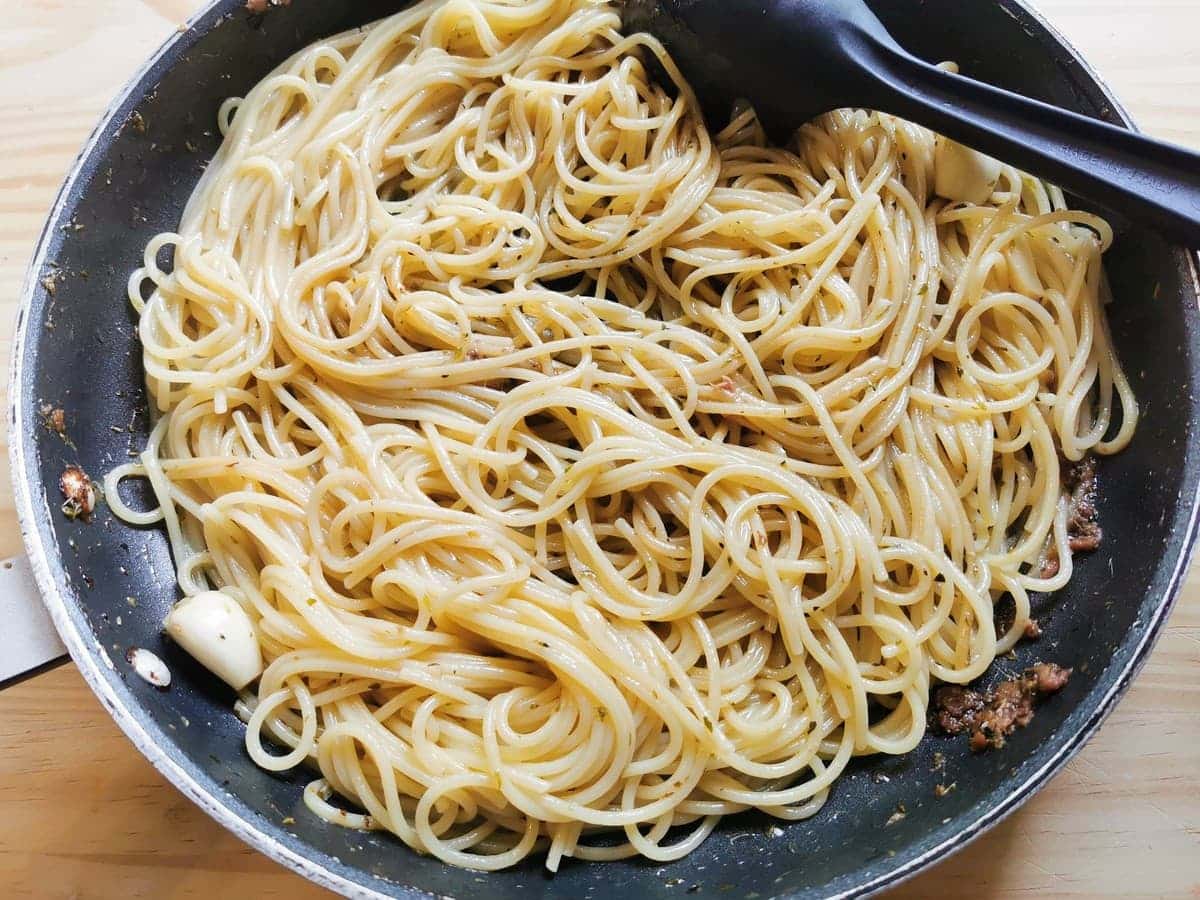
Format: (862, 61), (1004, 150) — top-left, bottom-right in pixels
(8, 0), (1200, 900)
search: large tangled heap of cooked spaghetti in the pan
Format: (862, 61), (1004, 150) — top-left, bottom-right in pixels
(107, 0), (1138, 869)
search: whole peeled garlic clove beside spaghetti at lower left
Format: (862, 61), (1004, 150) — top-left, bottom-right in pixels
(166, 590), (263, 690)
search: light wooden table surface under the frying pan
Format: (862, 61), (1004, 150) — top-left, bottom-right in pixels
(0, 0), (1200, 900)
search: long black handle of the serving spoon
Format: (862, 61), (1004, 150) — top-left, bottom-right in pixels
(851, 40), (1200, 247)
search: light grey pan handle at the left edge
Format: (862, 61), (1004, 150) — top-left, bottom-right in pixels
(0, 557), (67, 689)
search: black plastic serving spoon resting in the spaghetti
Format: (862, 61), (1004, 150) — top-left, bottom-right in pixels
(624, 0), (1200, 247)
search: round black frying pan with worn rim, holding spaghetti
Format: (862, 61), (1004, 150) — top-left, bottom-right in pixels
(11, 0), (1200, 900)
